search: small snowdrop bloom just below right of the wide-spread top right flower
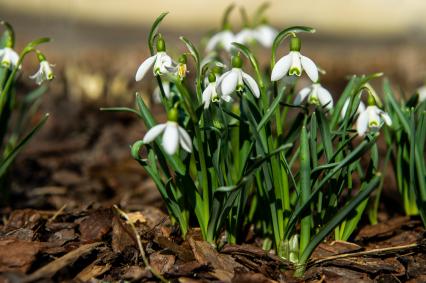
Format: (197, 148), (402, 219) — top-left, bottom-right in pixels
(294, 83), (333, 110)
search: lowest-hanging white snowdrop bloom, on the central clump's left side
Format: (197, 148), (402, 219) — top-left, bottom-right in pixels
(143, 109), (192, 155)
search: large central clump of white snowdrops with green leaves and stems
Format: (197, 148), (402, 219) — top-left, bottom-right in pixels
(105, 5), (425, 276)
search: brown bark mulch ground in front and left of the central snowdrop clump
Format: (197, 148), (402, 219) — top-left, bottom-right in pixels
(0, 65), (426, 283)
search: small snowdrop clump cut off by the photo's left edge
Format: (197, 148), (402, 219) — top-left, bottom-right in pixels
(0, 20), (54, 199)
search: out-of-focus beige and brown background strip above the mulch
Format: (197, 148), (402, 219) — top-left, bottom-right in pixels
(0, 0), (426, 96)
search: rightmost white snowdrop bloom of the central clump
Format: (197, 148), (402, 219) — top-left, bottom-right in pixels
(356, 105), (392, 136)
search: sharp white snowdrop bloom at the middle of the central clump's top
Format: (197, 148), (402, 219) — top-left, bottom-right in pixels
(217, 55), (260, 98)
